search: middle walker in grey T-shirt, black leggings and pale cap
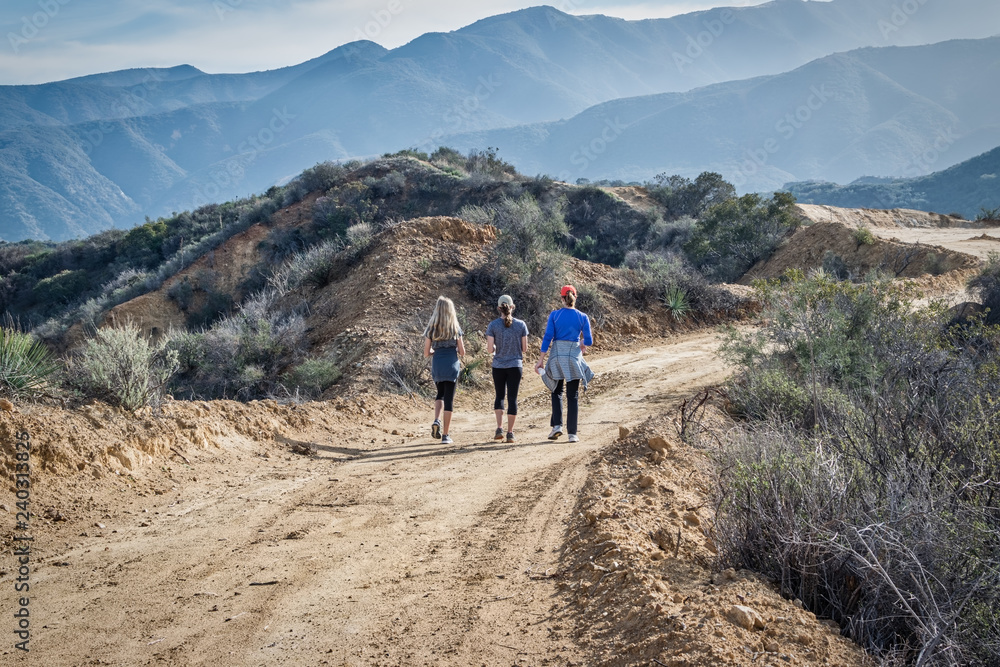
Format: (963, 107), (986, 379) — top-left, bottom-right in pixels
(486, 294), (528, 442)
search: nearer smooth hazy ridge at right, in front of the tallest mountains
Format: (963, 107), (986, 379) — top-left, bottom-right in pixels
(449, 37), (1000, 191)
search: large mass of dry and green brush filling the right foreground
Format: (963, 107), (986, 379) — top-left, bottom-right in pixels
(714, 273), (1000, 666)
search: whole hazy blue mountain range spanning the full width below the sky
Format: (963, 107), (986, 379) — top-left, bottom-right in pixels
(0, 0), (1000, 240)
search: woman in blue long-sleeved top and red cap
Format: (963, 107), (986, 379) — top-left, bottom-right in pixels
(535, 285), (594, 442)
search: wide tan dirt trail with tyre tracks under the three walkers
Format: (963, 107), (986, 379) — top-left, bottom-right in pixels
(3, 332), (725, 667)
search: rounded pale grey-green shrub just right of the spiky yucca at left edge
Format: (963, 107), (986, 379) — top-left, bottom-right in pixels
(67, 324), (178, 411)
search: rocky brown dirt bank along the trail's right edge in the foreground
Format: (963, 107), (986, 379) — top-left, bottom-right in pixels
(559, 417), (866, 667)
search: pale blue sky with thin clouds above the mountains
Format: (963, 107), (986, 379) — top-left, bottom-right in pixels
(0, 0), (764, 84)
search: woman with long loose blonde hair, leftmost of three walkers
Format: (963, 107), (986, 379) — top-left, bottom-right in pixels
(424, 296), (465, 445)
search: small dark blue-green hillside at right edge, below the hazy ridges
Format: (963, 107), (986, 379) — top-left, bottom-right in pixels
(785, 148), (1000, 220)
